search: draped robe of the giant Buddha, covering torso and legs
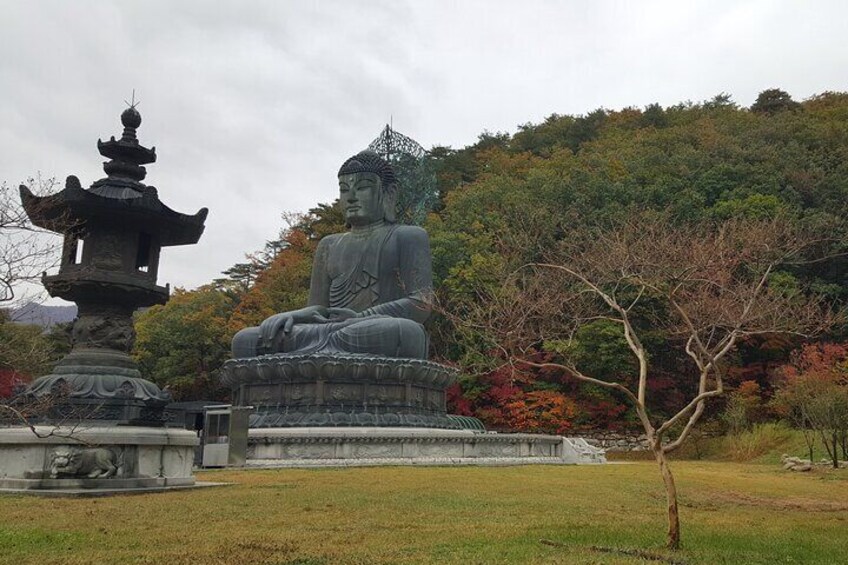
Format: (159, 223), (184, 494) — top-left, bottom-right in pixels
(233, 224), (433, 359)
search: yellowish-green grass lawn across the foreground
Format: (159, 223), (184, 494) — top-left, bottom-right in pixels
(0, 461), (848, 565)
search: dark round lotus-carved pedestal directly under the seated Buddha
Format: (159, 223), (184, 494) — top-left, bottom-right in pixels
(221, 353), (461, 429)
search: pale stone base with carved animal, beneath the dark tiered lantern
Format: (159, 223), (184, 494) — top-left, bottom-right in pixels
(0, 423), (198, 494)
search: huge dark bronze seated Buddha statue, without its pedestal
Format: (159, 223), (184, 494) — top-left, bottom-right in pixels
(232, 151), (433, 359)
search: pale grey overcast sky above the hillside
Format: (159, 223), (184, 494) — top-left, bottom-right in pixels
(0, 0), (848, 304)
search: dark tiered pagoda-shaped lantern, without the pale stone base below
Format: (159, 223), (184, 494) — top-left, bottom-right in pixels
(20, 107), (207, 425)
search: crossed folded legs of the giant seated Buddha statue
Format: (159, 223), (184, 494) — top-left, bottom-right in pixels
(233, 316), (428, 359)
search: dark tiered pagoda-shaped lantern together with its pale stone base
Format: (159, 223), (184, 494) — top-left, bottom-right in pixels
(0, 107), (207, 492)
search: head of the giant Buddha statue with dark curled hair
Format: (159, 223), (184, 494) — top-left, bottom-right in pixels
(339, 151), (398, 226)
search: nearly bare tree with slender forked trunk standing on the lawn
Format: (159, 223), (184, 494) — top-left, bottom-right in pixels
(454, 213), (837, 549)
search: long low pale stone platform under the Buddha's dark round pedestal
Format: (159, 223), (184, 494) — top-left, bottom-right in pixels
(247, 427), (606, 467)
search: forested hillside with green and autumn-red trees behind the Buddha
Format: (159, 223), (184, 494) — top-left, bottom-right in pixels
(135, 89), (848, 432)
